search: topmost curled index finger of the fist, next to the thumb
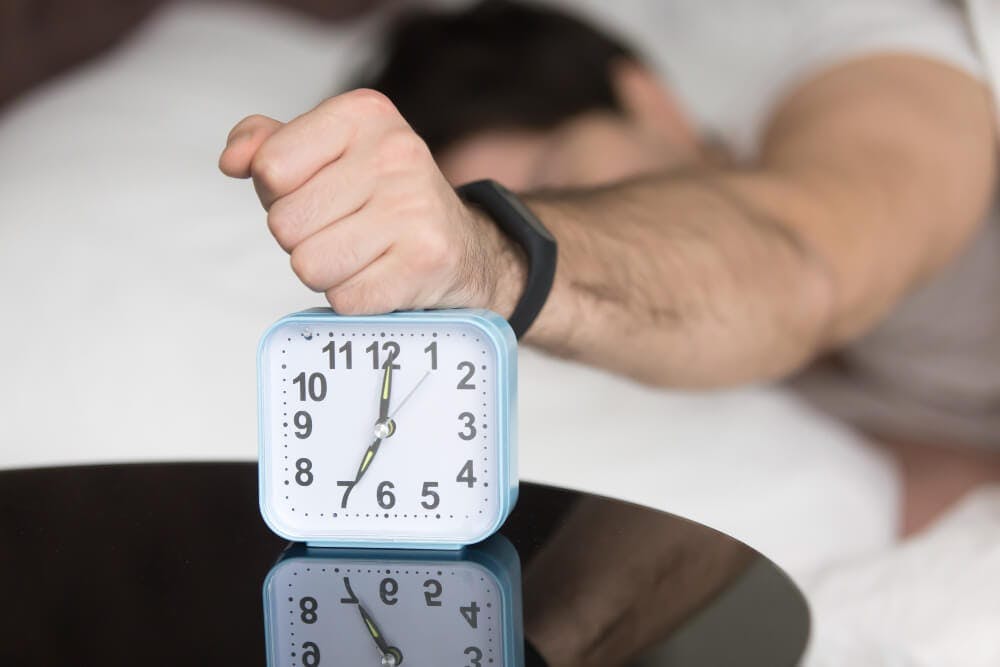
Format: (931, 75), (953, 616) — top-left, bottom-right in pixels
(250, 90), (405, 208)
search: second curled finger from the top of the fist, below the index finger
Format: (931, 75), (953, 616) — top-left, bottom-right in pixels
(267, 152), (375, 252)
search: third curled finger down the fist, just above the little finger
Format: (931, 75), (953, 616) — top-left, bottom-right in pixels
(291, 211), (395, 292)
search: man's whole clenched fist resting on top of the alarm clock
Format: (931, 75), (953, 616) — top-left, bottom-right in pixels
(219, 90), (524, 316)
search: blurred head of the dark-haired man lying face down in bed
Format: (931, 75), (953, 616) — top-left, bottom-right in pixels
(365, 0), (698, 189)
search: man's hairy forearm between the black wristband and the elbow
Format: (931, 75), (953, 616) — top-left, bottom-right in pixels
(527, 170), (833, 387)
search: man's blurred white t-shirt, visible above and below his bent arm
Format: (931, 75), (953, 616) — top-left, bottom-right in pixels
(554, 0), (1000, 446)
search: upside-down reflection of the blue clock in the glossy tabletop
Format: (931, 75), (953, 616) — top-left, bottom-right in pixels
(264, 535), (524, 667)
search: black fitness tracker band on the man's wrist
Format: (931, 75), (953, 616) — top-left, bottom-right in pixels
(456, 180), (556, 338)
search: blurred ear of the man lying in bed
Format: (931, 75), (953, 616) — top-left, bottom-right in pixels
(611, 60), (698, 148)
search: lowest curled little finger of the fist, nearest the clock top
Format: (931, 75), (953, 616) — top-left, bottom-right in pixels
(326, 250), (420, 315)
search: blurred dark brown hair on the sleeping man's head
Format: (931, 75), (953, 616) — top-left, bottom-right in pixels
(360, 0), (634, 153)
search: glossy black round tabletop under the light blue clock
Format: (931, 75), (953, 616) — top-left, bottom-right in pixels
(0, 463), (809, 667)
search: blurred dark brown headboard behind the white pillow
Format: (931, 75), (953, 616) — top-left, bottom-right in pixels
(0, 0), (385, 107)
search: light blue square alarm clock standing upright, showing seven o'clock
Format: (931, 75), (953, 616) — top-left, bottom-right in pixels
(258, 308), (517, 549)
